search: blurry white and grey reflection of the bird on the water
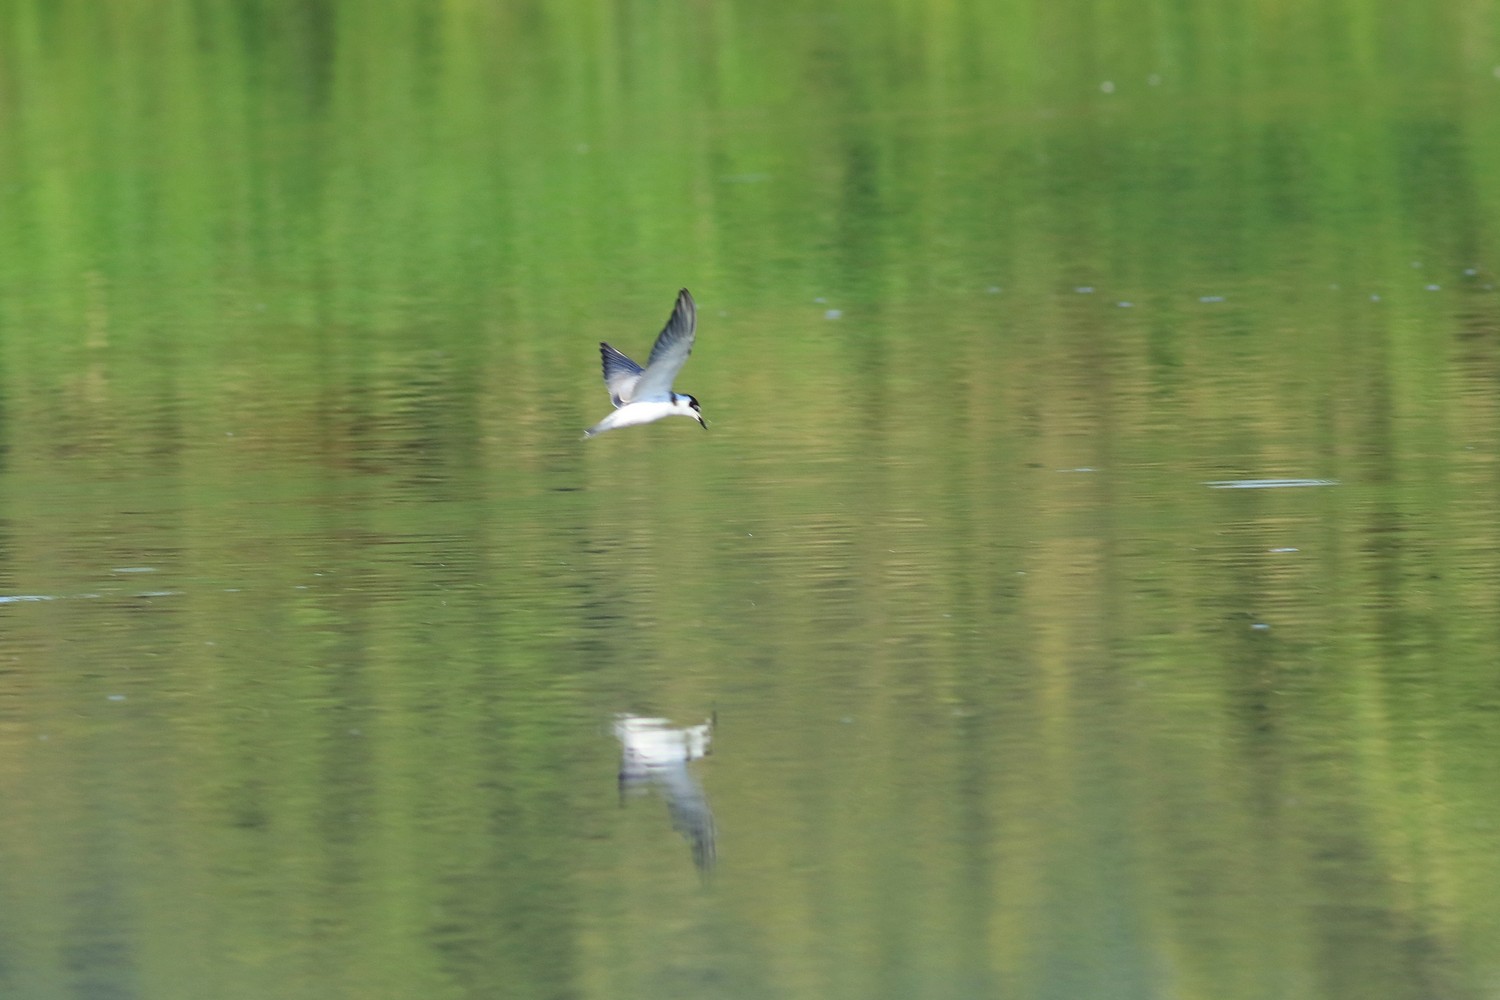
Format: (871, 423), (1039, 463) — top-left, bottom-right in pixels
(615, 714), (716, 876)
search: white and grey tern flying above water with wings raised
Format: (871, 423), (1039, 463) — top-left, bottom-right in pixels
(584, 288), (708, 438)
